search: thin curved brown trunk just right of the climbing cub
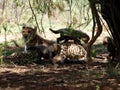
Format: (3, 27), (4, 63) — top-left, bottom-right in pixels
(87, 0), (102, 66)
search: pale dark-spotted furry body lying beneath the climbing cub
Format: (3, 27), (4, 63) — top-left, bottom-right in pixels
(60, 42), (87, 60)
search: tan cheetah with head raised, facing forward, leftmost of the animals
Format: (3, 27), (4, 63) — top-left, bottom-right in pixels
(22, 26), (55, 52)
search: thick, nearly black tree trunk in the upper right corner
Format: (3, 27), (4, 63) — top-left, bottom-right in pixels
(100, 0), (120, 59)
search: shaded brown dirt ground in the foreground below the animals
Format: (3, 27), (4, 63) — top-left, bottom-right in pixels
(0, 30), (120, 90)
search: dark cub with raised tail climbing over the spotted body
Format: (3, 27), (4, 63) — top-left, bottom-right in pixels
(49, 28), (90, 44)
